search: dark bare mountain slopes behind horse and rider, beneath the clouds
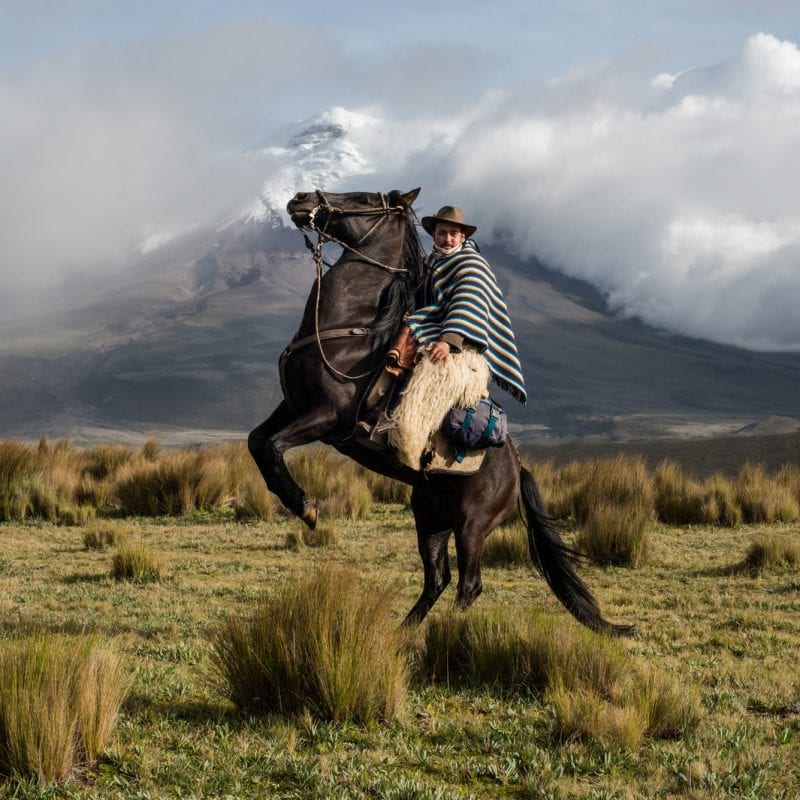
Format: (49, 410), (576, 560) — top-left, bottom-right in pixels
(0, 219), (800, 440)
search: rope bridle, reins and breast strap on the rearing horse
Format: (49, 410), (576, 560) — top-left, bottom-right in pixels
(294, 189), (410, 381)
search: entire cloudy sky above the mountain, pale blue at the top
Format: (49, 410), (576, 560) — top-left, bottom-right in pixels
(0, 0), (800, 351)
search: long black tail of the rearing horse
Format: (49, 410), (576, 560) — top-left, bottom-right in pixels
(520, 467), (633, 636)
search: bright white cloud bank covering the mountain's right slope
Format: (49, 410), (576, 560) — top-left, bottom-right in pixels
(332, 34), (800, 351)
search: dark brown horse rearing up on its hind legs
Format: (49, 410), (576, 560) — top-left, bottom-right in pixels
(248, 189), (628, 634)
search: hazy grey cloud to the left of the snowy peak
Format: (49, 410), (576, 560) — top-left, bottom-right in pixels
(0, 22), (348, 305)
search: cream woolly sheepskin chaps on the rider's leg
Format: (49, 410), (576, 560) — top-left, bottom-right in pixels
(389, 348), (491, 470)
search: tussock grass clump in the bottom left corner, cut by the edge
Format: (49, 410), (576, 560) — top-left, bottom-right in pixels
(0, 635), (129, 783)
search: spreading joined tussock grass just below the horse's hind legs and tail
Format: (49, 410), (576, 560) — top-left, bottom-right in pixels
(420, 609), (700, 749)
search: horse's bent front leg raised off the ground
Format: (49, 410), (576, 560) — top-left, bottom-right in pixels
(247, 401), (336, 528)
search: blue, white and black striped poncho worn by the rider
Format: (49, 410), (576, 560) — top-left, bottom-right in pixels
(406, 239), (527, 403)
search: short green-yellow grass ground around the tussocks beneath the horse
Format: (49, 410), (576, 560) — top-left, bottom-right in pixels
(0, 504), (800, 800)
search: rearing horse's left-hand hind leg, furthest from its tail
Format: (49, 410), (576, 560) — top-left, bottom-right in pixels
(404, 488), (452, 625)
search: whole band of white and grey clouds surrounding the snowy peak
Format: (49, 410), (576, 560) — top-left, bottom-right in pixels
(0, 23), (800, 351)
